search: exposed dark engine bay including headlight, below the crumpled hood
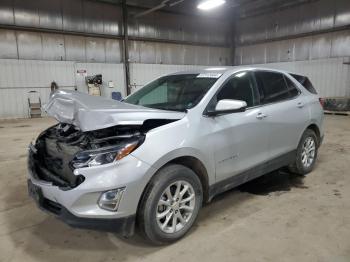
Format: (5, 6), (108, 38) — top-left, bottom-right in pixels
(29, 119), (176, 190)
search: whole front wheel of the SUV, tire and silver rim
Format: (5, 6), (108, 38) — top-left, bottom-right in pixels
(138, 164), (203, 245)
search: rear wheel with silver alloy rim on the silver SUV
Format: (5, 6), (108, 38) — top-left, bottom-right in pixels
(289, 129), (319, 175)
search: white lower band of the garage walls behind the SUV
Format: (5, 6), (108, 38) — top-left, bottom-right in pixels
(0, 58), (350, 118)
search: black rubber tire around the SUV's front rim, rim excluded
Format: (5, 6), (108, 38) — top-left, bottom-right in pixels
(142, 165), (203, 244)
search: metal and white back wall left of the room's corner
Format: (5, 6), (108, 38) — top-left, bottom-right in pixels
(0, 0), (232, 118)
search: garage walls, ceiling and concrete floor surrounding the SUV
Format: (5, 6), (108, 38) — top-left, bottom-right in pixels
(0, 0), (350, 262)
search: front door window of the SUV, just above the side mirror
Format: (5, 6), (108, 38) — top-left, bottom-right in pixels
(216, 72), (258, 107)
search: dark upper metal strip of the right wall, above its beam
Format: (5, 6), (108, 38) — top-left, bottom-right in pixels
(236, 0), (350, 44)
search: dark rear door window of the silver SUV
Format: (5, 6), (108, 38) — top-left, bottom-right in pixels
(255, 71), (289, 104)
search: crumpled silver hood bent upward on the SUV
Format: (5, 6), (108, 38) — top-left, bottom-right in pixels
(43, 90), (186, 132)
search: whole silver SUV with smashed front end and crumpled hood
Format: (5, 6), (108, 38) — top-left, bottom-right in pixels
(28, 67), (323, 244)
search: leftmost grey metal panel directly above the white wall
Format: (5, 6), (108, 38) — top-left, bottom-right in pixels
(0, 29), (18, 59)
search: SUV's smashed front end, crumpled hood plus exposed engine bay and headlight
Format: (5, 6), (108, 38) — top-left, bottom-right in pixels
(28, 90), (185, 190)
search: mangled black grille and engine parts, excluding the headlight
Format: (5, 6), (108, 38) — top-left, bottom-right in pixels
(28, 124), (145, 189)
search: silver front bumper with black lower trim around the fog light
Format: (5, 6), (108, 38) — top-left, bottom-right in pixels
(28, 145), (154, 236)
